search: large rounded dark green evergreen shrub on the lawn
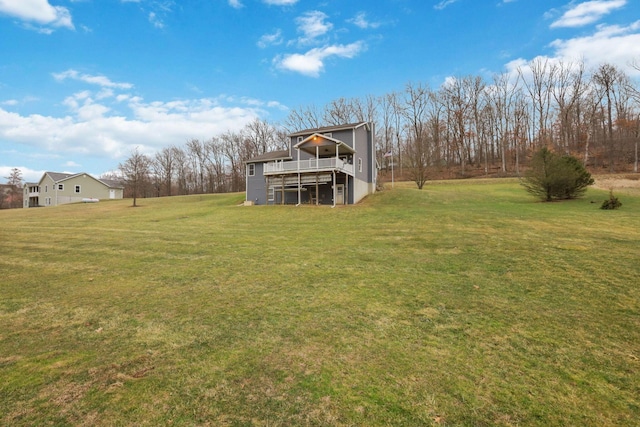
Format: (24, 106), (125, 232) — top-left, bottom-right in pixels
(521, 147), (593, 202)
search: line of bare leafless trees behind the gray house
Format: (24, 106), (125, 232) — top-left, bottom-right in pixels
(121, 58), (640, 197)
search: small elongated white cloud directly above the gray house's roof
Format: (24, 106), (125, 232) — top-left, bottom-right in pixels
(275, 42), (366, 77)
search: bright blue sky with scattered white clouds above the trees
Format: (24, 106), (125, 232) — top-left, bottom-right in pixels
(0, 0), (640, 182)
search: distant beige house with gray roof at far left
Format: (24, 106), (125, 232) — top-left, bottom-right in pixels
(23, 172), (124, 208)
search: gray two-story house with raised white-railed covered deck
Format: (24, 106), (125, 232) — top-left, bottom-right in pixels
(245, 122), (378, 206)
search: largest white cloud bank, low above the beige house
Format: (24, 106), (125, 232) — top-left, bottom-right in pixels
(0, 91), (283, 163)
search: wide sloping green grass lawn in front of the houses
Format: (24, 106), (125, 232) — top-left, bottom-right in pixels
(0, 180), (640, 426)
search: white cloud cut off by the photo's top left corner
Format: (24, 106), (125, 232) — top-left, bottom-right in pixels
(0, 0), (74, 33)
